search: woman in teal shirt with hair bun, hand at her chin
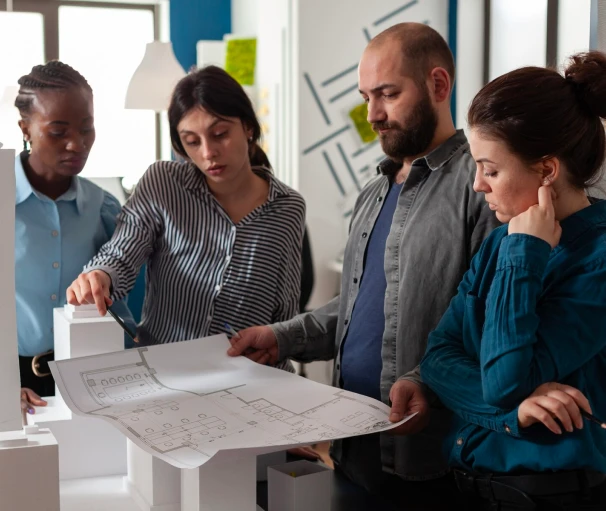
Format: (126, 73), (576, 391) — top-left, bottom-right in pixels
(421, 52), (606, 510)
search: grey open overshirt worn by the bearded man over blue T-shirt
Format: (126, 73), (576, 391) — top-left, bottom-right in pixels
(272, 130), (499, 480)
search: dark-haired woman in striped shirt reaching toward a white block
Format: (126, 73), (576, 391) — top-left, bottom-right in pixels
(67, 66), (305, 365)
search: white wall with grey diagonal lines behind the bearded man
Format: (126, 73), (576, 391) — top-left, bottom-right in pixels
(292, 0), (448, 306)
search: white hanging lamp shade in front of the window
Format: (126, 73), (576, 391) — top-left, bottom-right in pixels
(124, 41), (185, 112)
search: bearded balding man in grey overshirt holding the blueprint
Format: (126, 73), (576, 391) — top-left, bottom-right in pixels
(229, 23), (498, 509)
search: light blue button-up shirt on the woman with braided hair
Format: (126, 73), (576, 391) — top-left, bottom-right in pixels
(15, 156), (135, 357)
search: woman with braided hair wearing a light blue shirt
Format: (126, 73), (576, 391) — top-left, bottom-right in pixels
(15, 61), (134, 411)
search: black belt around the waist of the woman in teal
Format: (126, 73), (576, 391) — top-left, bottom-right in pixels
(454, 470), (606, 504)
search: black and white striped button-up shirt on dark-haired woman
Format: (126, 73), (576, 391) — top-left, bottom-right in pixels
(86, 161), (305, 352)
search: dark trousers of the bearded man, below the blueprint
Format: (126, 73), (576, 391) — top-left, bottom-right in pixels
(335, 434), (464, 511)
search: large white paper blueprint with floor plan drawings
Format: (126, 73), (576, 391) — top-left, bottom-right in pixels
(51, 335), (411, 468)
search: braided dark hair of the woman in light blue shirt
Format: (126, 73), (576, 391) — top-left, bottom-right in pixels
(15, 60), (93, 118)
